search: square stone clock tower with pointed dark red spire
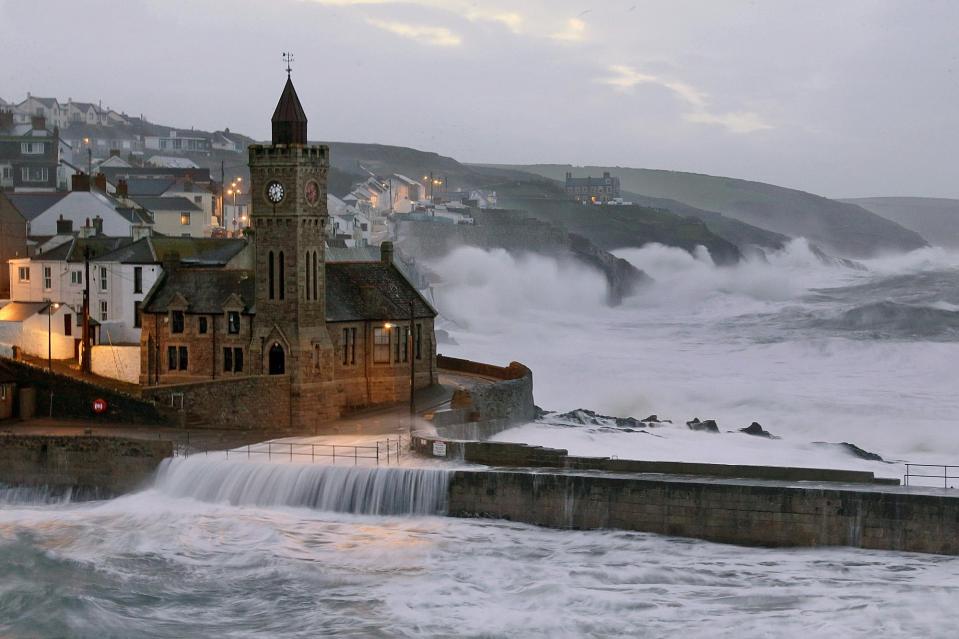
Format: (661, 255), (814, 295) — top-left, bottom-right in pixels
(249, 69), (332, 423)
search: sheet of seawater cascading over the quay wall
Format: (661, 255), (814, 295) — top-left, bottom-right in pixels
(155, 456), (450, 515)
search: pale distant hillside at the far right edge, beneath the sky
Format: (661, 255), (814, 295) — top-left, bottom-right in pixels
(840, 197), (959, 248)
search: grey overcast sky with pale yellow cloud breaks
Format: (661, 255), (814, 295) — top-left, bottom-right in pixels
(0, 0), (959, 197)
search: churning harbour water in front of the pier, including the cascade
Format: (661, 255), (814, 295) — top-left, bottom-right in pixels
(0, 457), (959, 638)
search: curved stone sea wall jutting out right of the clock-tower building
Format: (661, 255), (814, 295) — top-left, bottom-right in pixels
(436, 355), (536, 425)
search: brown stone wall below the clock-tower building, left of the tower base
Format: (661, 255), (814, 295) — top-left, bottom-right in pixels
(143, 375), (291, 430)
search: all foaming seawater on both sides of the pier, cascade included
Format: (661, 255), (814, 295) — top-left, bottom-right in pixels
(0, 241), (959, 638)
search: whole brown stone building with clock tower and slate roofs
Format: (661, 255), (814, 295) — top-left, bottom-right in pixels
(140, 77), (436, 425)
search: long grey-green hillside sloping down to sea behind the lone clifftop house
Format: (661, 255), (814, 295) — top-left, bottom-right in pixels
(498, 164), (927, 257)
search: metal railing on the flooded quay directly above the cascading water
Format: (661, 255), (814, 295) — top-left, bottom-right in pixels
(173, 435), (403, 466)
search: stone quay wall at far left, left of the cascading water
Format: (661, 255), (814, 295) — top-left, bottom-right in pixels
(0, 434), (173, 499)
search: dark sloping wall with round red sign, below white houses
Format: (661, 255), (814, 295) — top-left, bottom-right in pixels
(3, 358), (170, 425)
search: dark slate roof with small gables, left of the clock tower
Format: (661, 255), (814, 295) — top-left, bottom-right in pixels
(143, 268), (254, 314)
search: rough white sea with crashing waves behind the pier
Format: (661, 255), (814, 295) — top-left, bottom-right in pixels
(436, 240), (959, 477)
